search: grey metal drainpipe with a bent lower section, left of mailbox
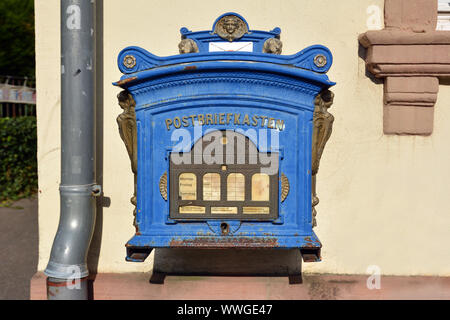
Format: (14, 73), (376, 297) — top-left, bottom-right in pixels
(44, 0), (101, 300)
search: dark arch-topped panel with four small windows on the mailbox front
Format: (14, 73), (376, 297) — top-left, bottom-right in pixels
(169, 130), (278, 220)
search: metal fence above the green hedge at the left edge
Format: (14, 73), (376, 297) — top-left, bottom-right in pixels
(0, 76), (36, 117)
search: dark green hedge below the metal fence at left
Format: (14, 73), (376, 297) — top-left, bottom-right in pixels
(0, 117), (37, 205)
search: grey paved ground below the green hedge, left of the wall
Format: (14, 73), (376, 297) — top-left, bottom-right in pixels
(0, 199), (39, 300)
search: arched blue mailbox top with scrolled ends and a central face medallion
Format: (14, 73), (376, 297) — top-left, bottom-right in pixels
(114, 12), (334, 88)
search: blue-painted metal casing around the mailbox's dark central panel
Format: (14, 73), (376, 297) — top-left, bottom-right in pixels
(114, 13), (335, 261)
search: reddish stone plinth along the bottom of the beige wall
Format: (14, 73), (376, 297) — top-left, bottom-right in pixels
(31, 272), (450, 300)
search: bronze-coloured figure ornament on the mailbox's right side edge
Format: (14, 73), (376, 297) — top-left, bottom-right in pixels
(311, 90), (334, 227)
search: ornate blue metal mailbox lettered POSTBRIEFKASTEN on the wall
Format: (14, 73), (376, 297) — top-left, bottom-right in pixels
(114, 13), (334, 282)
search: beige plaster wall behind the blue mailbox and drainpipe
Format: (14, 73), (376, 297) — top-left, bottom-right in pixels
(36, 0), (450, 276)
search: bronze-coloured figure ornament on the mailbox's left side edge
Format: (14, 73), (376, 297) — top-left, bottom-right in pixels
(117, 90), (137, 227)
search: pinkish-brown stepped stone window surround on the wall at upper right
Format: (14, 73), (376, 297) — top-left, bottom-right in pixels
(359, 0), (450, 135)
